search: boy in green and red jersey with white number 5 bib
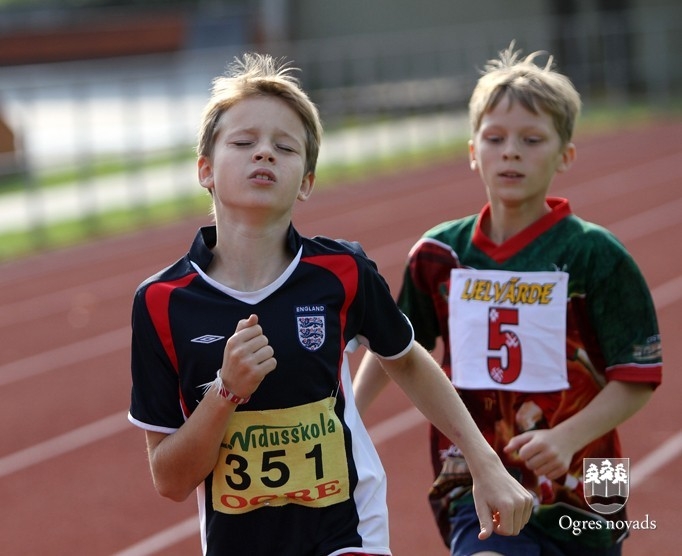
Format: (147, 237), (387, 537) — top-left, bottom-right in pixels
(354, 43), (662, 556)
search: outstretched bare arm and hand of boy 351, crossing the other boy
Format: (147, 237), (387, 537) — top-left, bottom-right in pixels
(378, 342), (532, 539)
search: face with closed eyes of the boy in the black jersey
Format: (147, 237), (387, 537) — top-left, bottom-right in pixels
(198, 96), (314, 218)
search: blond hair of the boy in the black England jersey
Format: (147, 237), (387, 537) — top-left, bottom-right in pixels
(197, 53), (322, 173)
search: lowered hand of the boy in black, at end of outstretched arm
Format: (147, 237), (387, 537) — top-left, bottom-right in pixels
(473, 465), (533, 540)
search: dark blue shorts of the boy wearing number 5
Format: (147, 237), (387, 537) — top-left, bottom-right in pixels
(450, 504), (622, 556)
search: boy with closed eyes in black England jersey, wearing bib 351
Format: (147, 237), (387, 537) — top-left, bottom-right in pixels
(129, 55), (531, 556)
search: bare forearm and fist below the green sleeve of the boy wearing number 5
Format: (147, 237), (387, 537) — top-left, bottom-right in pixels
(504, 380), (653, 479)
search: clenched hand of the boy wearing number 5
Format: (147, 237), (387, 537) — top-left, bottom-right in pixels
(504, 429), (573, 480)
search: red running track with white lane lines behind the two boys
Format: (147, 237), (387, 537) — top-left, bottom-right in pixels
(0, 122), (682, 556)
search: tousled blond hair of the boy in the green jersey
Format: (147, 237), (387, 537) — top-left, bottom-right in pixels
(469, 41), (581, 145)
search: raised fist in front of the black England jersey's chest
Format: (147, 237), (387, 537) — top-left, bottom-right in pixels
(220, 315), (277, 398)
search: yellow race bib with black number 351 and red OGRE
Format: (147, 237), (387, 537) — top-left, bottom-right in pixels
(213, 397), (350, 514)
